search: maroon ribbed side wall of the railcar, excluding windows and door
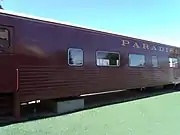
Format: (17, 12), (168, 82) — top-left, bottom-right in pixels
(0, 12), (180, 102)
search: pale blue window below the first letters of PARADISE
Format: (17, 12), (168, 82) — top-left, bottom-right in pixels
(129, 54), (145, 67)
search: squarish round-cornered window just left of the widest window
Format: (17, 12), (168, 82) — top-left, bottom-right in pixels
(68, 48), (83, 66)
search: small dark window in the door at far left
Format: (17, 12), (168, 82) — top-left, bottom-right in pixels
(0, 27), (9, 48)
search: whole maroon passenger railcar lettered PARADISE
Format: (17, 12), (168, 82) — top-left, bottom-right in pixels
(0, 10), (180, 116)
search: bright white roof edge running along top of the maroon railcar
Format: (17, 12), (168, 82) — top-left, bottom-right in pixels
(0, 9), (179, 48)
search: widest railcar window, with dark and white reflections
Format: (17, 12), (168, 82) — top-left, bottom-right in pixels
(96, 51), (120, 66)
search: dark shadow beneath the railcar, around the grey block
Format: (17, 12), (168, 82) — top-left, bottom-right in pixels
(1, 86), (177, 126)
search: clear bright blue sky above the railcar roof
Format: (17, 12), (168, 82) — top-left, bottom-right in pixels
(2, 0), (180, 46)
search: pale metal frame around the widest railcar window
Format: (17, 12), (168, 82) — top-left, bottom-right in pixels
(95, 50), (121, 67)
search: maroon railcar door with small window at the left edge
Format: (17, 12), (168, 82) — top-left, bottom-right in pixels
(0, 25), (17, 93)
